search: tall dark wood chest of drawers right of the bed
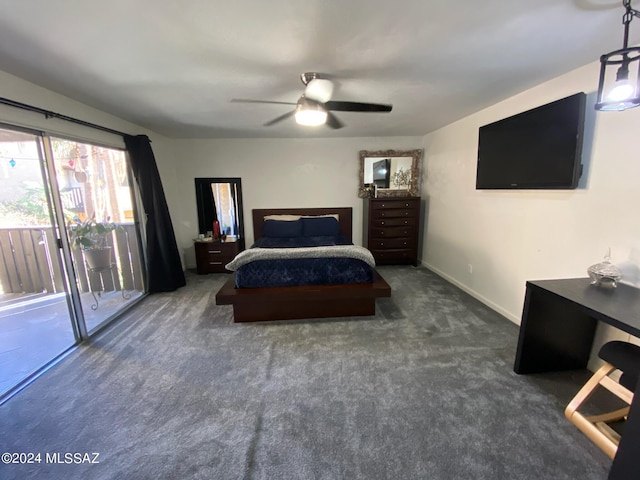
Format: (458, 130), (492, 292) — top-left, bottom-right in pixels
(362, 197), (420, 266)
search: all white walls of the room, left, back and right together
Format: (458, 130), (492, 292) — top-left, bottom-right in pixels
(0, 63), (640, 366)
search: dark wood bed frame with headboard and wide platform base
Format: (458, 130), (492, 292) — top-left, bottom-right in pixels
(216, 207), (391, 322)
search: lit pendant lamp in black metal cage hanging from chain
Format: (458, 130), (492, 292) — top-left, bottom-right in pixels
(595, 0), (640, 111)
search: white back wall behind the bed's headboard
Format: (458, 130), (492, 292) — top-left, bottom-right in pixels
(164, 137), (422, 267)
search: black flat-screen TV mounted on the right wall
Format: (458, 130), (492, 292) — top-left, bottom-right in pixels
(476, 92), (586, 190)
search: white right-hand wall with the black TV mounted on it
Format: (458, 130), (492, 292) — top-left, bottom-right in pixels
(422, 57), (640, 364)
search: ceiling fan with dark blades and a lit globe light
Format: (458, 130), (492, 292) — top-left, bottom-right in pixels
(231, 72), (393, 129)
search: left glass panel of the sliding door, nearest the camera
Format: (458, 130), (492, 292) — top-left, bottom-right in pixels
(0, 125), (78, 395)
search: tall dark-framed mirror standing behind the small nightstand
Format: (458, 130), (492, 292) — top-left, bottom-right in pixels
(195, 177), (244, 250)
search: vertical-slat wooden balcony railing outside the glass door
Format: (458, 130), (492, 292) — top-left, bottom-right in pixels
(0, 223), (144, 293)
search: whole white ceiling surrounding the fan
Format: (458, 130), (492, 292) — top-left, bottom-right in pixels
(0, 0), (640, 138)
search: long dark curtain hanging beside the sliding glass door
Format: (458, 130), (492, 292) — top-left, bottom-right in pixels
(124, 135), (186, 293)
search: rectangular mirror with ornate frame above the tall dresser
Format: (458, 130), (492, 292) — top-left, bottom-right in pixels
(358, 149), (422, 198)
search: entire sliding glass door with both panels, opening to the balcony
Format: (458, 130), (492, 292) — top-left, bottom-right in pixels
(0, 126), (145, 401)
